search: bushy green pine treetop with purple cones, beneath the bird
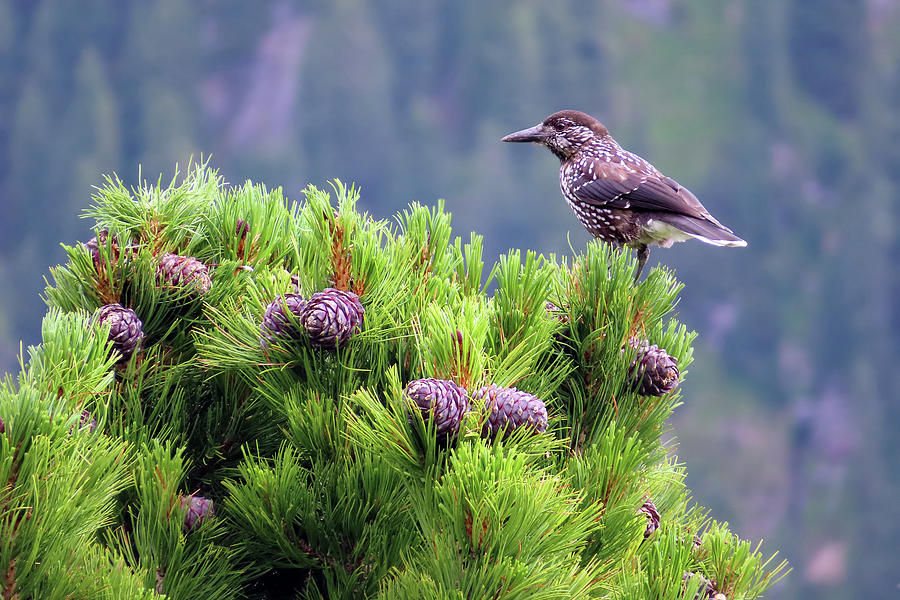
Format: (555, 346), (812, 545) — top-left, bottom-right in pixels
(0, 165), (786, 600)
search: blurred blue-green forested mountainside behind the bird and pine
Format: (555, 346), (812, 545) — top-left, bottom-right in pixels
(0, 0), (900, 599)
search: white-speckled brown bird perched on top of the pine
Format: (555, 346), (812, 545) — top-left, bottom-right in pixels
(500, 110), (747, 282)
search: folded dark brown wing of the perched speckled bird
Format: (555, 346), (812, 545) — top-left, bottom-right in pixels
(571, 157), (716, 223)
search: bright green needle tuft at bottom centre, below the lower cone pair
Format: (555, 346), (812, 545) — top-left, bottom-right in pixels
(380, 441), (608, 599)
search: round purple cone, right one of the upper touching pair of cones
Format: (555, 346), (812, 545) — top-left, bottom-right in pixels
(300, 288), (366, 350)
